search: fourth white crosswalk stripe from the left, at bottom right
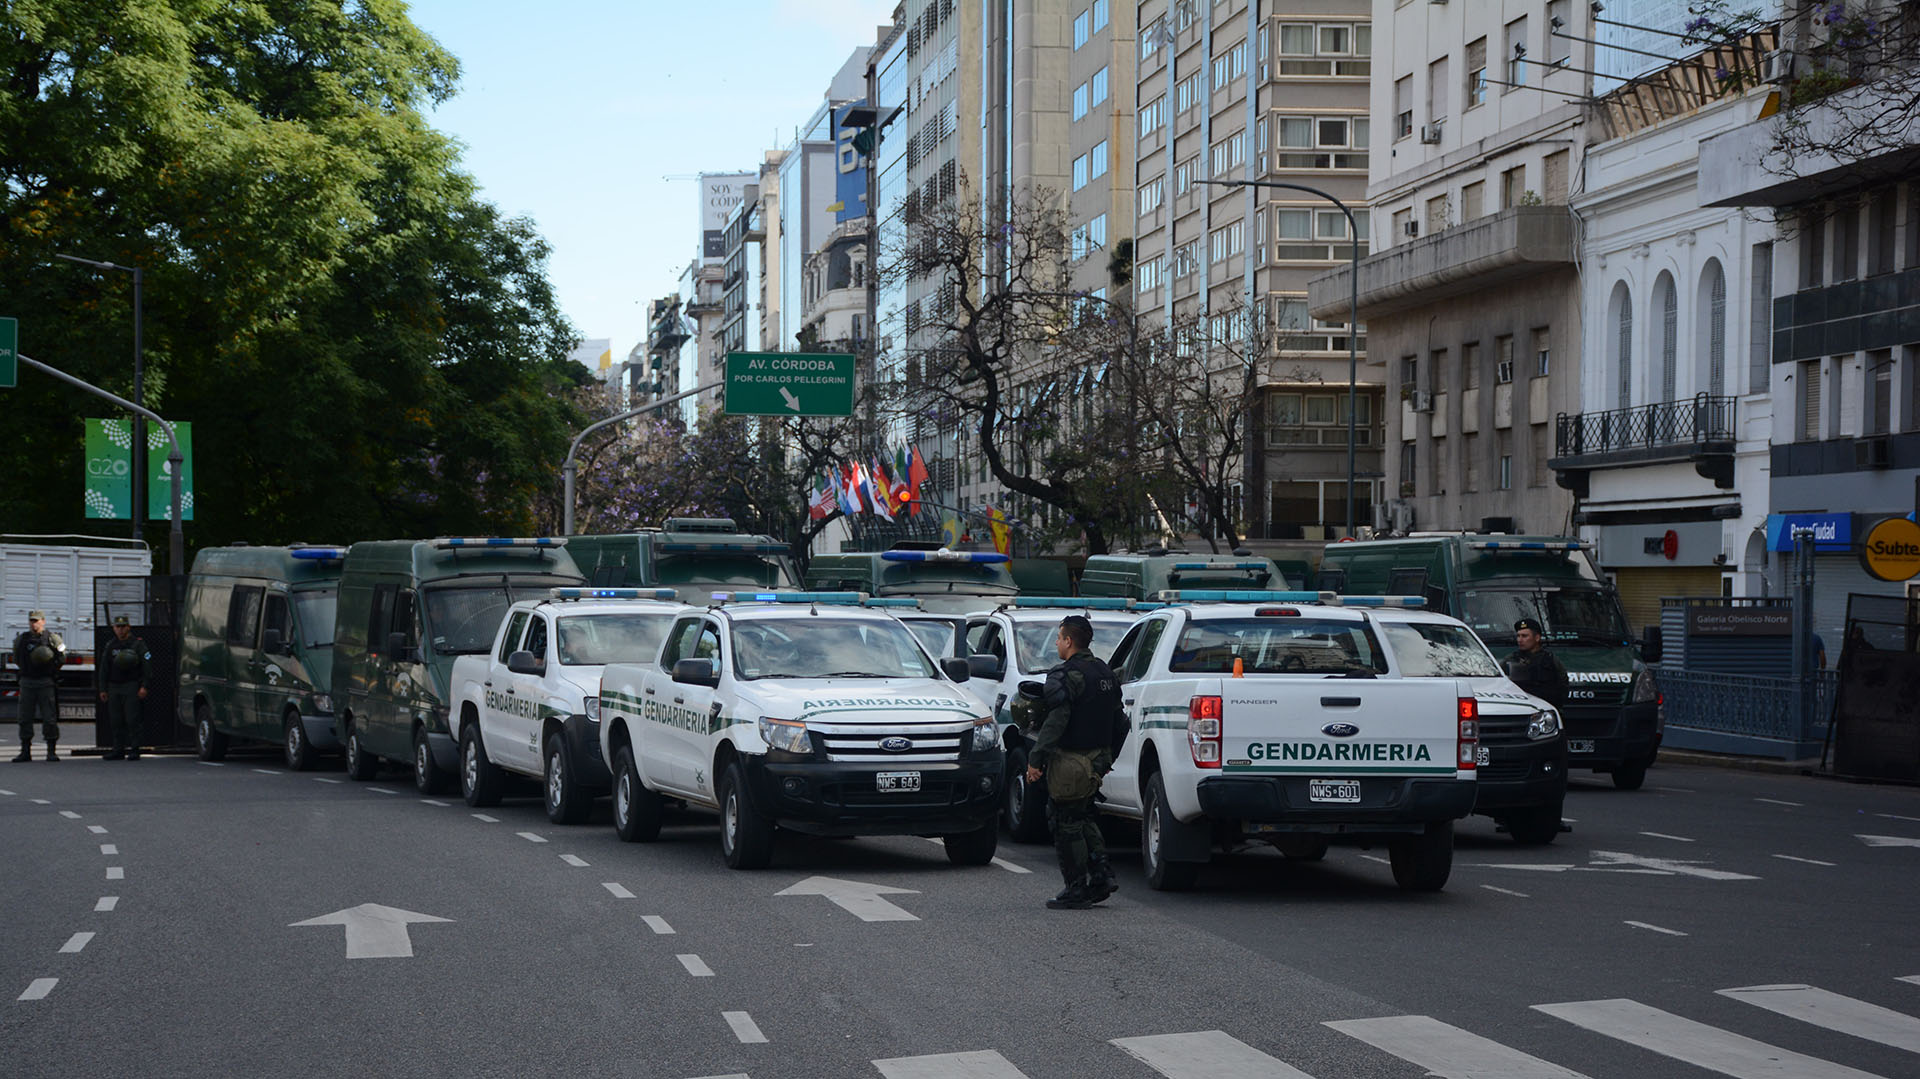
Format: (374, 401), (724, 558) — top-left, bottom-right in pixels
(1534, 998), (1878, 1079)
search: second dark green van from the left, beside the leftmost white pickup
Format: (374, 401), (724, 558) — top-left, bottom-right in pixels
(334, 536), (586, 795)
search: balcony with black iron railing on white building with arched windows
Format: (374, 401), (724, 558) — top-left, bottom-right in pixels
(1548, 394), (1740, 497)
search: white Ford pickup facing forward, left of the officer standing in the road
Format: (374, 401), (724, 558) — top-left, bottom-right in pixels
(599, 591), (1004, 870)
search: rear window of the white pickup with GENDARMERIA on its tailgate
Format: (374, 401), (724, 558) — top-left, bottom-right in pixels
(1167, 616), (1386, 674)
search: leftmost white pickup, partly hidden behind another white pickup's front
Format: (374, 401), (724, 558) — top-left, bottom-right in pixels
(451, 587), (685, 824)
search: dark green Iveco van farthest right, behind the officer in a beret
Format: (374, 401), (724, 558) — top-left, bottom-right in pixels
(1319, 534), (1663, 791)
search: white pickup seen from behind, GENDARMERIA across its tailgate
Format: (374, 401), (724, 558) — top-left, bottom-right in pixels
(1100, 591), (1478, 891)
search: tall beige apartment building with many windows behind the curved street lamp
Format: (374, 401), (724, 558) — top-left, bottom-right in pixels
(1131, 0), (1382, 540)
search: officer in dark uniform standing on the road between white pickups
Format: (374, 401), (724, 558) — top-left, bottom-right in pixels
(1027, 614), (1127, 910)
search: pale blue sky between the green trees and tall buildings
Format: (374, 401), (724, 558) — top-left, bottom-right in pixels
(411, 0), (895, 361)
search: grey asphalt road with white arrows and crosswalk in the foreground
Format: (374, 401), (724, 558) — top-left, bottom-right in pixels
(0, 753), (1920, 1079)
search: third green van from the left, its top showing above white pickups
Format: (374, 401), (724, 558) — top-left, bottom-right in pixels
(566, 516), (801, 605)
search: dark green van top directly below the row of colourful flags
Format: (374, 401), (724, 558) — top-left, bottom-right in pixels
(806, 541), (1020, 614)
